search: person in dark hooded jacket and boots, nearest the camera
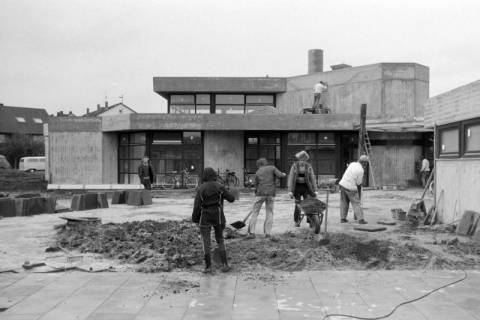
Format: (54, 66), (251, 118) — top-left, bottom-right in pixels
(192, 167), (235, 273)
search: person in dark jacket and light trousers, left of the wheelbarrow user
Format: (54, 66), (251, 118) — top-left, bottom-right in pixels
(248, 158), (286, 238)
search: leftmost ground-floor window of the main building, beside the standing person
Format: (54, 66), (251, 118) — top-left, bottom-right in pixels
(118, 132), (146, 184)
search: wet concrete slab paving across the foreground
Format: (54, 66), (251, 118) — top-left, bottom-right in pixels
(0, 270), (480, 320)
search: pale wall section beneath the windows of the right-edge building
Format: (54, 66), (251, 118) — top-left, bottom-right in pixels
(435, 159), (480, 223)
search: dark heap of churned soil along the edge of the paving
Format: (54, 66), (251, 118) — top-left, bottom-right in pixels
(57, 220), (479, 272)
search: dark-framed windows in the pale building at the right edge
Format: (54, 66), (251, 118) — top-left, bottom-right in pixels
(437, 119), (480, 158)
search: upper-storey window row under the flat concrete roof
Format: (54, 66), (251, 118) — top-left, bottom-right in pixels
(169, 94), (275, 114)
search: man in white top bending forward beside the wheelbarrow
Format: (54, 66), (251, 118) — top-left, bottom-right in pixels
(339, 155), (368, 224)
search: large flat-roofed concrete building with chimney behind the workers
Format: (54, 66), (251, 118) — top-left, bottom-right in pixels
(47, 50), (431, 185)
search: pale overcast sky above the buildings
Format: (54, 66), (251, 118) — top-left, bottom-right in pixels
(0, 0), (480, 115)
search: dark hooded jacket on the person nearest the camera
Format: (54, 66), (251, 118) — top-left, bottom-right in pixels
(192, 168), (235, 226)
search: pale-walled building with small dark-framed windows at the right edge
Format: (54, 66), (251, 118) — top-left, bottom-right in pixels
(425, 80), (480, 223)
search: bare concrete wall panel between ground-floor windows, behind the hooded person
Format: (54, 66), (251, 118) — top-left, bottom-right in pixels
(204, 131), (245, 186)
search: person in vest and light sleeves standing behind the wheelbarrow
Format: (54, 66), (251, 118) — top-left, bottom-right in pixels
(288, 151), (317, 227)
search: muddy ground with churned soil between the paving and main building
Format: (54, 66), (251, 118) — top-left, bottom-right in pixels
(0, 189), (480, 278)
